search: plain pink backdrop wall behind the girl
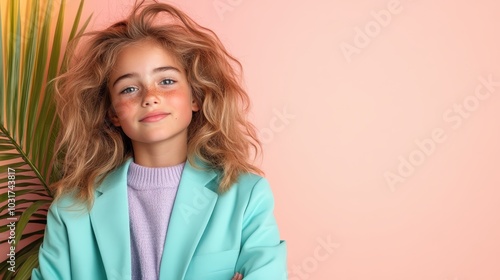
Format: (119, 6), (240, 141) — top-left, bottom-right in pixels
(68, 0), (500, 280)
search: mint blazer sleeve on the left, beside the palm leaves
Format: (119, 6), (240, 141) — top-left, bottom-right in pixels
(31, 202), (71, 280)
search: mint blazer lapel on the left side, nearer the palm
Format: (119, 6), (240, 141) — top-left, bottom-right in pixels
(90, 158), (132, 279)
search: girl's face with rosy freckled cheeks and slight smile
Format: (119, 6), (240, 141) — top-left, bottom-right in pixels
(108, 40), (199, 153)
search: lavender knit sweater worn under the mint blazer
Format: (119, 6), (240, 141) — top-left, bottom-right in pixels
(127, 162), (186, 280)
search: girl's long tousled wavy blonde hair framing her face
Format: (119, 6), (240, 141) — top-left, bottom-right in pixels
(50, 1), (263, 206)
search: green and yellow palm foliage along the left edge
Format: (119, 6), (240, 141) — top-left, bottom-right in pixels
(0, 0), (90, 279)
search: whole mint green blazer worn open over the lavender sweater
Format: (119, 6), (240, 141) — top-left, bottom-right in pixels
(32, 159), (287, 280)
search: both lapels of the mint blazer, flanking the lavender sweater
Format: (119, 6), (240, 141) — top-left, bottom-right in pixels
(90, 158), (218, 279)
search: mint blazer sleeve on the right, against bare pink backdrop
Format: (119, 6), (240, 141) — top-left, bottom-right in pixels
(236, 178), (287, 280)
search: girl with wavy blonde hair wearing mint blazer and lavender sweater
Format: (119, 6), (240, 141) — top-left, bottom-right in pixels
(32, 2), (287, 280)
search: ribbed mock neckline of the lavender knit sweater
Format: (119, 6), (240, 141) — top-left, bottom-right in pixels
(127, 161), (186, 190)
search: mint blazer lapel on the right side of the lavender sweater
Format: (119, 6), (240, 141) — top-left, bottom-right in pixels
(159, 161), (218, 280)
